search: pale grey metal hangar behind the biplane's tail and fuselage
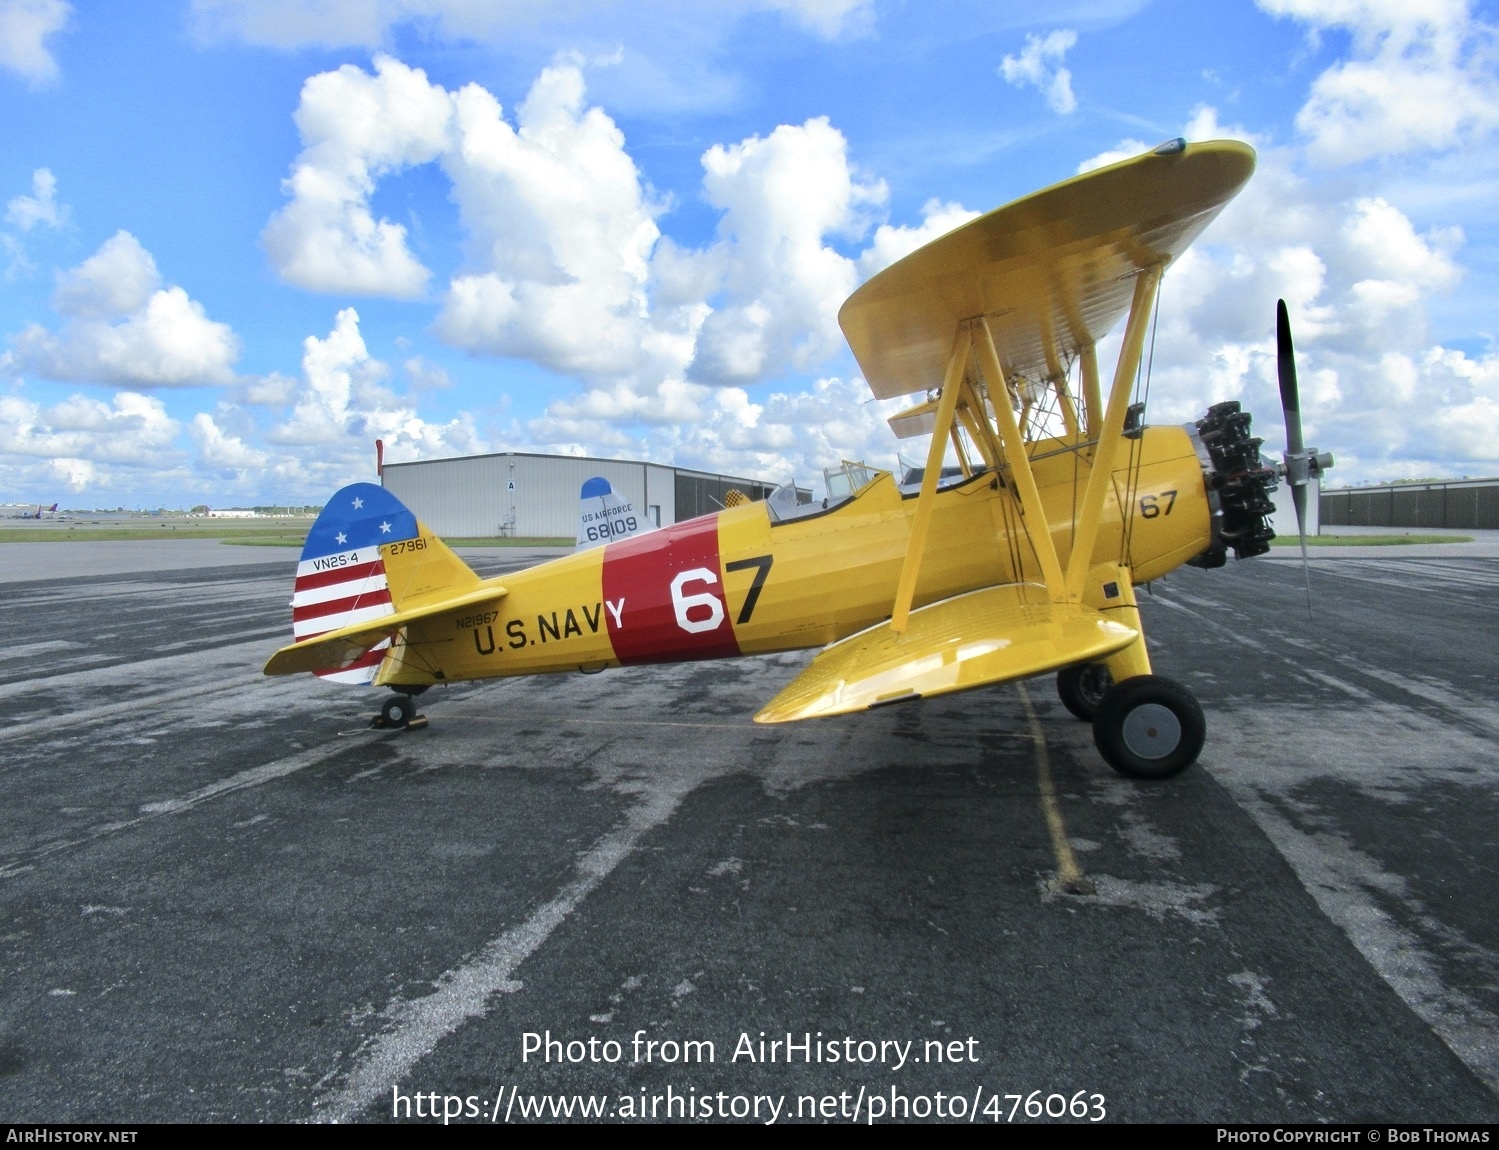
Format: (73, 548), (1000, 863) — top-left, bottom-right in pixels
(381, 451), (775, 538)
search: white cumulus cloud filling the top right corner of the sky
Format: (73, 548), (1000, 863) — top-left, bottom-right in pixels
(1259, 0), (1499, 163)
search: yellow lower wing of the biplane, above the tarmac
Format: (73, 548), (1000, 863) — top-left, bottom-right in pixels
(754, 583), (1139, 723)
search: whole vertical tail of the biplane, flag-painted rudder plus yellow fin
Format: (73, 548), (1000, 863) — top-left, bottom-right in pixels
(291, 483), (480, 684)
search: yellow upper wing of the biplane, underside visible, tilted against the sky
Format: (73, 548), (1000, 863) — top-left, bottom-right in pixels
(838, 139), (1255, 399)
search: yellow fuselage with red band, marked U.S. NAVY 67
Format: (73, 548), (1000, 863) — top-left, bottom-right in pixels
(378, 427), (1211, 685)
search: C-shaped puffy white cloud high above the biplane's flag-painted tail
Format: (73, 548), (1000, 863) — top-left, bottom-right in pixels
(261, 55), (453, 298)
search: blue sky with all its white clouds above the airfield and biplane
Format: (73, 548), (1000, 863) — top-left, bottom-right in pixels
(0, 0), (1499, 507)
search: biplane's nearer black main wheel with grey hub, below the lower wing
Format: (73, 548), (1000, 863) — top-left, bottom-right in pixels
(1093, 675), (1208, 778)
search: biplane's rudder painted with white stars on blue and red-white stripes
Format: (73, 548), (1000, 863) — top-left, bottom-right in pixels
(291, 483), (420, 684)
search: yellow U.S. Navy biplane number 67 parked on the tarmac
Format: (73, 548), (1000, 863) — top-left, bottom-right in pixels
(265, 141), (1331, 778)
